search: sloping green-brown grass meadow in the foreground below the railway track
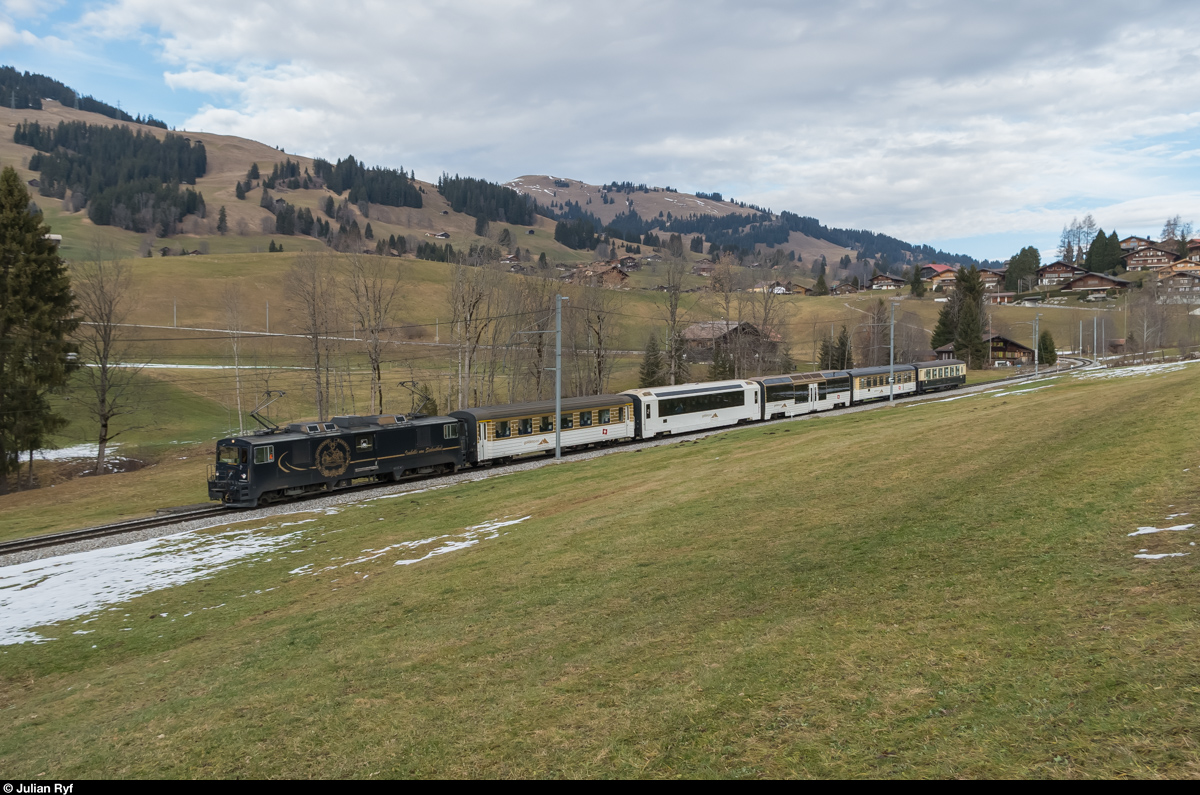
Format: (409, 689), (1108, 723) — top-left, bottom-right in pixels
(0, 366), (1200, 778)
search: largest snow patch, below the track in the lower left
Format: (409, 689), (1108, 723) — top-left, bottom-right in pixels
(0, 528), (298, 645)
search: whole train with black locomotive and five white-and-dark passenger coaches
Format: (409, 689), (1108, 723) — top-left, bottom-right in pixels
(208, 359), (966, 508)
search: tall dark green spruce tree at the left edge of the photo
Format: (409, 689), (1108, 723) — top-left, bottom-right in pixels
(0, 167), (78, 492)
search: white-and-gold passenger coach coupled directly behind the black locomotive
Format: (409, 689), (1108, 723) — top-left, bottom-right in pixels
(450, 395), (634, 464)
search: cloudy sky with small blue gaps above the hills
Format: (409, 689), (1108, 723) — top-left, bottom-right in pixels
(0, 0), (1200, 258)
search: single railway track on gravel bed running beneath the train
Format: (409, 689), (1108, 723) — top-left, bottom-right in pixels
(0, 357), (1092, 557)
